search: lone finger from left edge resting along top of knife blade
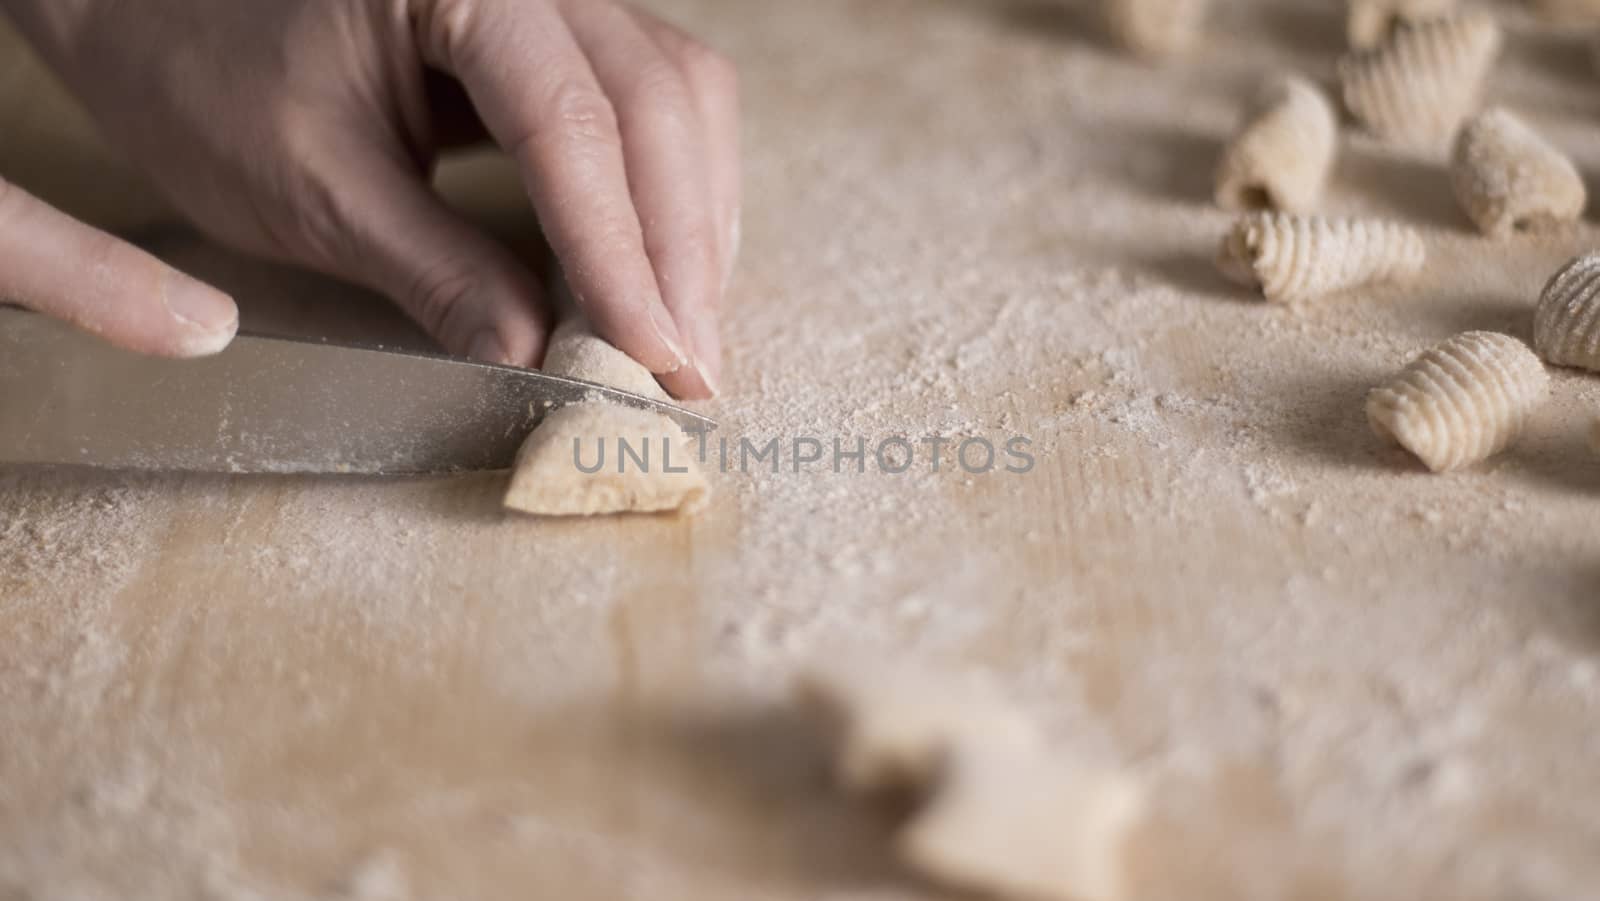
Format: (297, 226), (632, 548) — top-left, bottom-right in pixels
(0, 181), (238, 357)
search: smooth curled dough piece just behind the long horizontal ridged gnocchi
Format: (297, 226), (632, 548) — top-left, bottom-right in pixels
(1216, 75), (1339, 213)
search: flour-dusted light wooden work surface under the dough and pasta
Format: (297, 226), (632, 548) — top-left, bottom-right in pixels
(9, 0), (1600, 899)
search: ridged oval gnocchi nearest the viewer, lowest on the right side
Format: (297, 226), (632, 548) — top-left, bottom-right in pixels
(1366, 331), (1549, 472)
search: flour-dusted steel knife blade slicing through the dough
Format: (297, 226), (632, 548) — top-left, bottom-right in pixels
(0, 306), (717, 474)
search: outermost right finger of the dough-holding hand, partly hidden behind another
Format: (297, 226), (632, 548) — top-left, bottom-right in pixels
(637, 11), (744, 293)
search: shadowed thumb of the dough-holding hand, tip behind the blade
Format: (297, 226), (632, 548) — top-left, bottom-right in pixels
(312, 141), (550, 366)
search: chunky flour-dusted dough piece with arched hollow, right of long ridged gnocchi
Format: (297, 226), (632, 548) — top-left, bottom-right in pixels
(1450, 107), (1589, 237)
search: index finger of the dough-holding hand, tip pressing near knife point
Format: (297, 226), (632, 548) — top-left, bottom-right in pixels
(406, 0), (688, 389)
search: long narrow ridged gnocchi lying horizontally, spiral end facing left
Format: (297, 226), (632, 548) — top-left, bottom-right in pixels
(1218, 213), (1426, 304)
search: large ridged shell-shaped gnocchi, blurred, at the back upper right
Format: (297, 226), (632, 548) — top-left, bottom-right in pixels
(1339, 10), (1502, 150)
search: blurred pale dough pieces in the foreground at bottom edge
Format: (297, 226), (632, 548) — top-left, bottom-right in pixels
(798, 664), (1146, 901)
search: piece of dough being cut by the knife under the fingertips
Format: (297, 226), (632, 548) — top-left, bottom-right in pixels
(504, 318), (710, 515)
